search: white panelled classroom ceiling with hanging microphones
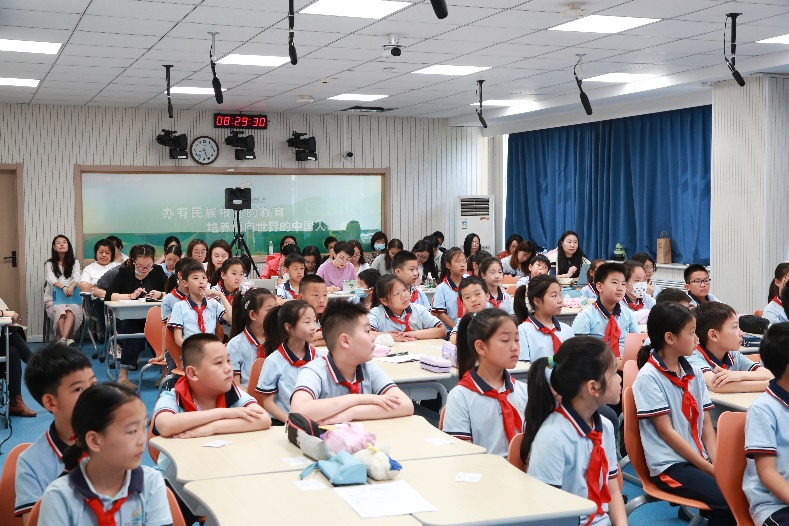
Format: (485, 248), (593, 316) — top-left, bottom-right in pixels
(0, 0), (789, 125)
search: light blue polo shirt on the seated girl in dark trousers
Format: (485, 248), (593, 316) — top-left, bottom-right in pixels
(633, 351), (714, 477)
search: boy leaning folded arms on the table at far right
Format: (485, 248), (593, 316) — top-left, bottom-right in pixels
(688, 301), (773, 393)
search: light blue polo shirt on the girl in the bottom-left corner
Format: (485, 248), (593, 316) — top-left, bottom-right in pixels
(38, 459), (173, 526)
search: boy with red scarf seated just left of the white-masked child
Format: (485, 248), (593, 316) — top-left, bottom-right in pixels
(572, 263), (640, 371)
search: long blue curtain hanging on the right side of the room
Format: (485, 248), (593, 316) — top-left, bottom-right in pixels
(505, 106), (712, 265)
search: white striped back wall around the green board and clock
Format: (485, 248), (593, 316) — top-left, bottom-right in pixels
(0, 104), (488, 335)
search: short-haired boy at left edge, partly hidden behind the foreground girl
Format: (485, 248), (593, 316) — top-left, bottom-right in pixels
(14, 343), (96, 524)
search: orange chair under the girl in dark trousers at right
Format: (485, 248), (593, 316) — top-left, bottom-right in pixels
(622, 387), (710, 526)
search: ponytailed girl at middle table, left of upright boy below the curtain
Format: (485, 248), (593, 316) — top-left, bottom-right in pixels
(515, 274), (574, 362)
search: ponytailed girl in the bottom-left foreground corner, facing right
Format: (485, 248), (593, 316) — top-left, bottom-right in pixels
(38, 383), (173, 526)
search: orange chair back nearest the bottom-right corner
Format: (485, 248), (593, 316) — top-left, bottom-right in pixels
(715, 411), (754, 526)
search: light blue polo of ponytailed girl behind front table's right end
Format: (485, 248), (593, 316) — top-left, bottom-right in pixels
(444, 369), (528, 458)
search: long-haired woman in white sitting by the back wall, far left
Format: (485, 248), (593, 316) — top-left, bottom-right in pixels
(44, 235), (82, 345)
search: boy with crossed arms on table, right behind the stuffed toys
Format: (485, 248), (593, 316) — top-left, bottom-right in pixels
(290, 301), (414, 424)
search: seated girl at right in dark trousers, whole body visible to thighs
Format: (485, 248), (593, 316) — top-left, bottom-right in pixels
(633, 303), (735, 526)
